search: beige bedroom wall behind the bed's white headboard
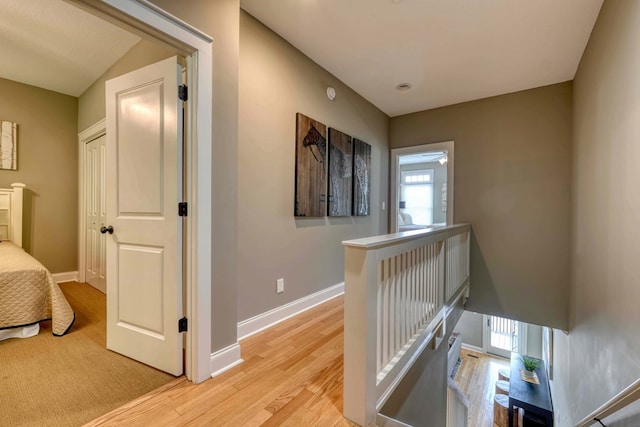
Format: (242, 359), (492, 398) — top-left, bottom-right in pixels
(0, 79), (78, 273)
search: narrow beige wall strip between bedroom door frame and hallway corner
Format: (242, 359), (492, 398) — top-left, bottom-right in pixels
(146, 0), (240, 351)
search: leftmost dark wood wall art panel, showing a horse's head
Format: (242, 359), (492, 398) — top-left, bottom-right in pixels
(294, 113), (327, 217)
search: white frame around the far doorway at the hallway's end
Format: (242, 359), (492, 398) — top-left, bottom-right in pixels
(389, 141), (454, 233)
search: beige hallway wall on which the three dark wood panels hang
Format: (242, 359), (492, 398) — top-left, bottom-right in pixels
(238, 12), (389, 320)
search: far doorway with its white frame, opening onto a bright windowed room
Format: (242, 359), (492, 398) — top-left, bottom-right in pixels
(389, 141), (454, 233)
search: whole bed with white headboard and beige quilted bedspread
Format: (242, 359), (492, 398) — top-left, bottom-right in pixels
(0, 184), (75, 340)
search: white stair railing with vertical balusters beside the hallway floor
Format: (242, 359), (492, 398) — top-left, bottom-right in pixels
(343, 224), (470, 426)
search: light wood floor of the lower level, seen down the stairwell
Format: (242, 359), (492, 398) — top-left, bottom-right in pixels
(455, 349), (509, 427)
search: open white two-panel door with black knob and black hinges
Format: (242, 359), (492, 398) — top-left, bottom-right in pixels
(104, 57), (183, 375)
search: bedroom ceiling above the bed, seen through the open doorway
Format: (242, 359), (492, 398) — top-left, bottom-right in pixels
(0, 0), (140, 96)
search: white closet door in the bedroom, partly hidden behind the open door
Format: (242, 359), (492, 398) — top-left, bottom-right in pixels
(84, 135), (107, 293)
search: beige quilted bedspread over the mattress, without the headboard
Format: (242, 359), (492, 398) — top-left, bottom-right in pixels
(0, 241), (75, 336)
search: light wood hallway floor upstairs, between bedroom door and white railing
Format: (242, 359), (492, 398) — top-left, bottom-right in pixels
(87, 297), (353, 426)
